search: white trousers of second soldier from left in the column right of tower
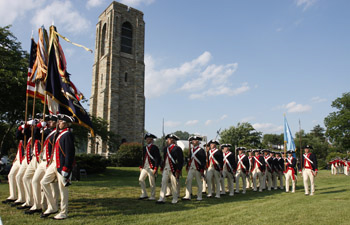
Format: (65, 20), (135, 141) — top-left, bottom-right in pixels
(159, 168), (179, 201)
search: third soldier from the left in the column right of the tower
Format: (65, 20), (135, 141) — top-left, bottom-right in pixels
(182, 136), (206, 201)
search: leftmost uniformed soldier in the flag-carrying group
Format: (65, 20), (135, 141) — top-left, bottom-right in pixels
(2, 124), (25, 205)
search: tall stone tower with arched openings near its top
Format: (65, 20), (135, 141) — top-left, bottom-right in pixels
(88, 2), (145, 155)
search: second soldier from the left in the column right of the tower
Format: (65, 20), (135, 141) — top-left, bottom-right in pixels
(156, 134), (184, 204)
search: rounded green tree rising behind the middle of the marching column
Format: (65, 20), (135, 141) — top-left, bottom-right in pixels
(220, 123), (262, 148)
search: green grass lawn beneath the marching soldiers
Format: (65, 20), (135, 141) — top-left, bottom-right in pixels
(0, 168), (350, 225)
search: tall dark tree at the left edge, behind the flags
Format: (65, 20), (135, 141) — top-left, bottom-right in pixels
(0, 26), (29, 154)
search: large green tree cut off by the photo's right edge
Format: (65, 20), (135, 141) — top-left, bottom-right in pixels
(324, 92), (350, 152)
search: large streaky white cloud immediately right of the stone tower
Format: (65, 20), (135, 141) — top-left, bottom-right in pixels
(145, 51), (250, 99)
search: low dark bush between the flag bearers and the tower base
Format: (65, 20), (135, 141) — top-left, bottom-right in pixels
(75, 154), (109, 174)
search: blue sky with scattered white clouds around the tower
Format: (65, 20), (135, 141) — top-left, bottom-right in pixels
(0, 0), (350, 139)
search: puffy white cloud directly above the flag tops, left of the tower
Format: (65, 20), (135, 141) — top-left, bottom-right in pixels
(31, 0), (90, 34)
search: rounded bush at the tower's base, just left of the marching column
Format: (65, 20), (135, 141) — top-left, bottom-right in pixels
(111, 143), (142, 166)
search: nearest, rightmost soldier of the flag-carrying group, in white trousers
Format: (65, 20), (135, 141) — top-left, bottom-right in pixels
(40, 114), (75, 220)
